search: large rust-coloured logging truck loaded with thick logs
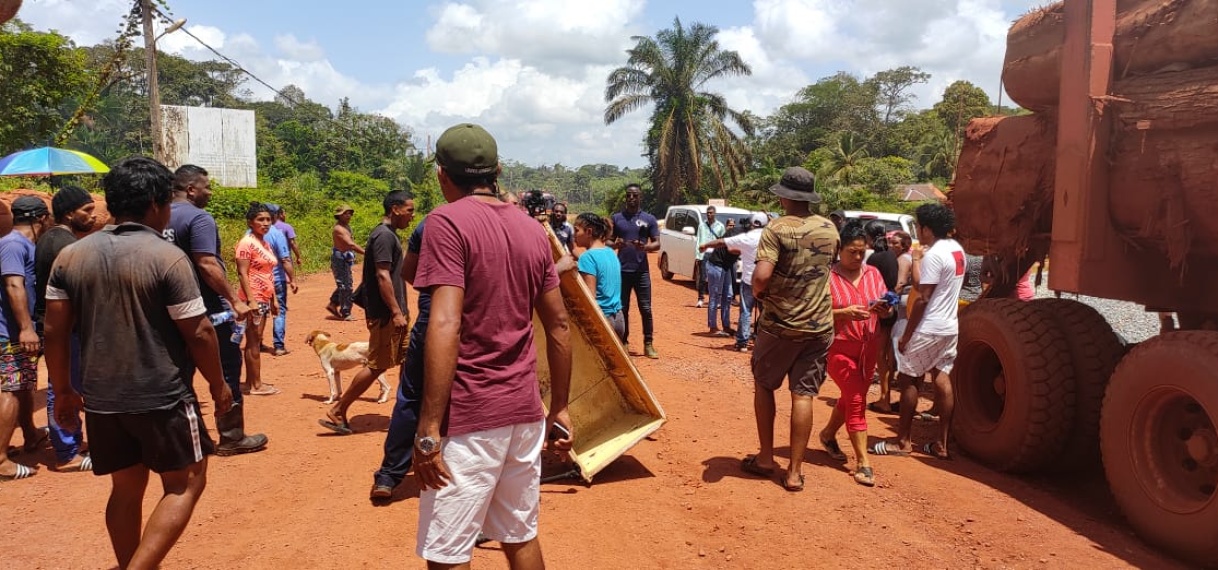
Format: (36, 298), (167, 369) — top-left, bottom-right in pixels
(951, 0), (1218, 565)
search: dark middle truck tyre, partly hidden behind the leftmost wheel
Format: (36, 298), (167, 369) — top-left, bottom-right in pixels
(1033, 298), (1125, 473)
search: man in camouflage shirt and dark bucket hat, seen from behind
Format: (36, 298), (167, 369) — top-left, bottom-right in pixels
(742, 167), (838, 491)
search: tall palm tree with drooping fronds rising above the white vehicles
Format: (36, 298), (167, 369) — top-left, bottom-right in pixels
(604, 18), (753, 209)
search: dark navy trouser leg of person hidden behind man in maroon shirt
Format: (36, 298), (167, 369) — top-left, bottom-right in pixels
(373, 322), (428, 488)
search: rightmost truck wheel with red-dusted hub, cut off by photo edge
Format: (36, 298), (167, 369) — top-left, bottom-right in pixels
(1100, 331), (1218, 565)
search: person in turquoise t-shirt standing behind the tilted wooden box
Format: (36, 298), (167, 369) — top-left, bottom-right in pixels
(575, 212), (626, 340)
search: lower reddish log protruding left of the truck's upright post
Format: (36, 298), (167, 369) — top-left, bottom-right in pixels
(951, 114), (1056, 259)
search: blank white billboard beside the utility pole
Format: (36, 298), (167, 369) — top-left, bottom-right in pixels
(161, 105), (258, 188)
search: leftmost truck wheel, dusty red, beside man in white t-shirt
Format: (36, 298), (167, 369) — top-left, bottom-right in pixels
(951, 298), (1074, 473)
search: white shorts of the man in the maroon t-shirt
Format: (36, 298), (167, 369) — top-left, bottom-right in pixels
(417, 420), (546, 564)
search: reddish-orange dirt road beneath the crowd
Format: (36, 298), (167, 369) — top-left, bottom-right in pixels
(0, 255), (1183, 569)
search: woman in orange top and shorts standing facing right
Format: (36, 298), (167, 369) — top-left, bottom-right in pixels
(236, 202), (279, 396)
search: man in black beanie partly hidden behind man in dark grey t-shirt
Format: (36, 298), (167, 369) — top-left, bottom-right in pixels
(34, 186), (97, 471)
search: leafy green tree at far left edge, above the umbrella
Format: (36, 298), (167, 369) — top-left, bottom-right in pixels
(0, 19), (88, 151)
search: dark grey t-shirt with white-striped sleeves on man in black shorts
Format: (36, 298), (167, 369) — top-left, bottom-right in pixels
(46, 223), (206, 414)
